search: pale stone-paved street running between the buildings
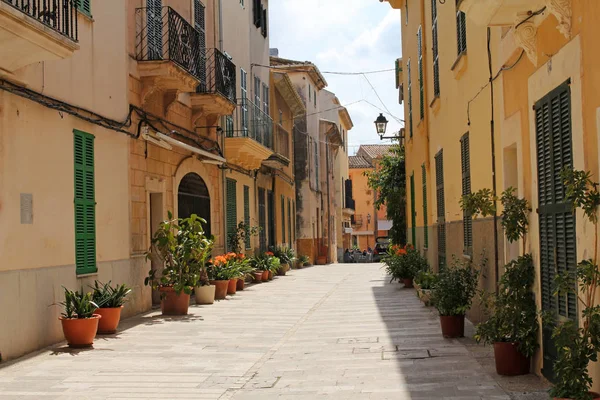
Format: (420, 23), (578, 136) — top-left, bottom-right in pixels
(0, 264), (542, 400)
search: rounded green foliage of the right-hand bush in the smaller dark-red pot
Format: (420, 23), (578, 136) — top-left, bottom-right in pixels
(431, 257), (479, 316)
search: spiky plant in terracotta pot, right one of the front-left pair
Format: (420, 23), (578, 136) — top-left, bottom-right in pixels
(92, 281), (131, 334)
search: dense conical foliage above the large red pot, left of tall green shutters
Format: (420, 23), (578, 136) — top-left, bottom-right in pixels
(475, 254), (539, 357)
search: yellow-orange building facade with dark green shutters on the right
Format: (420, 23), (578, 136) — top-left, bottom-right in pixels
(389, 0), (600, 390)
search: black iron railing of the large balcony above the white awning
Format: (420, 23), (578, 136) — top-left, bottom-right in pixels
(135, 7), (206, 80)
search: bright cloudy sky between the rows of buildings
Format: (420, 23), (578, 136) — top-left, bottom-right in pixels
(269, 0), (404, 154)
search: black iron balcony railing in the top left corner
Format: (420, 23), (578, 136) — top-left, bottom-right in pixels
(2, 0), (78, 42)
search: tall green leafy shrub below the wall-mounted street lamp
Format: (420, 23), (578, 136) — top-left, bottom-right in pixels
(365, 145), (406, 243)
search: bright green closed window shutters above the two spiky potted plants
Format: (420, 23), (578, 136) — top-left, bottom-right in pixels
(73, 130), (98, 274)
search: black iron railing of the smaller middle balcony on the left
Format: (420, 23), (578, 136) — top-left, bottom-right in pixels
(196, 49), (237, 103)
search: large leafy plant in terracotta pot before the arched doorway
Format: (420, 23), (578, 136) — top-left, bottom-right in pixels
(145, 212), (212, 315)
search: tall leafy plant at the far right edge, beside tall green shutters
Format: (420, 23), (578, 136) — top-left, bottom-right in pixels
(545, 169), (600, 400)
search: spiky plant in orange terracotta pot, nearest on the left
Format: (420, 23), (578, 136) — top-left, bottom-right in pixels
(59, 287), (102, 348)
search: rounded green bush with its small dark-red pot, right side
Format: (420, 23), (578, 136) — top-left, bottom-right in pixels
(431, 258), (479, 338)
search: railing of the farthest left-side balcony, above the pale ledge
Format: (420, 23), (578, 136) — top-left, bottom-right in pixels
(227, 97), (273, 150)
